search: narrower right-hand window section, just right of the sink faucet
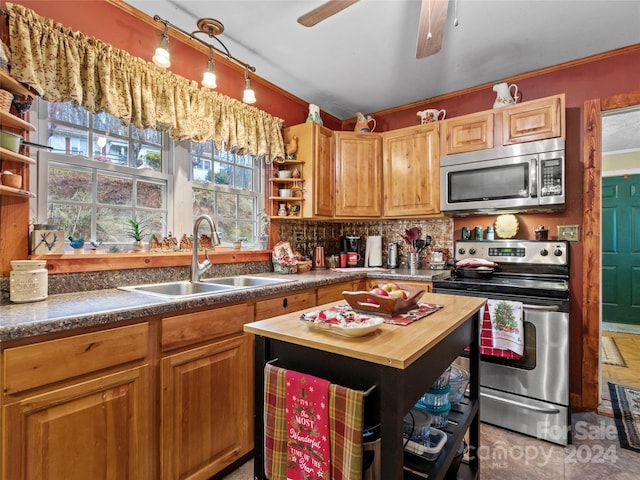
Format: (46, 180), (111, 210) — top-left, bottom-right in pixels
(190, 142), (262, 243)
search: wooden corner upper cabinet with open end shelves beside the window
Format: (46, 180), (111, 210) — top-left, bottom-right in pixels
(284, 122), (335, 218)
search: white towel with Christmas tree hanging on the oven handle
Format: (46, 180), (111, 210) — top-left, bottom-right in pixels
(485, 300), (524, 357)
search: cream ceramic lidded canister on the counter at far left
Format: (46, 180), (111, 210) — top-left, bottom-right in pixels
(9, 260), (49, 303)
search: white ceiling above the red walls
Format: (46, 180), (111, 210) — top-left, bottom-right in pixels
(125, 0), (640, 120)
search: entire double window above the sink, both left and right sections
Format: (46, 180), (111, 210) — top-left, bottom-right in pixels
(36, 100), (263, 245)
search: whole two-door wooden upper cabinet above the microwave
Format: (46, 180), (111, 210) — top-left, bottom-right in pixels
(440, 94), (565, 155)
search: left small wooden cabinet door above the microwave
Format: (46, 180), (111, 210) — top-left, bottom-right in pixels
(440, 110), (493, 155)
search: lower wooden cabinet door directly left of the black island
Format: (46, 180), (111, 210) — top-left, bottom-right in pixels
(160, 334), (252, 480)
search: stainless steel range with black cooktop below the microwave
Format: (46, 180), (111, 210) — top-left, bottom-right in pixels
(433, 240), (571, 445)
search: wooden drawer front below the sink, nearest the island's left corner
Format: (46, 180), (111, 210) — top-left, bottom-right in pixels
(160, 304), (252, 351)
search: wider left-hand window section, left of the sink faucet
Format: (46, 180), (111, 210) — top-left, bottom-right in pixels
(37, 101), (171, 244)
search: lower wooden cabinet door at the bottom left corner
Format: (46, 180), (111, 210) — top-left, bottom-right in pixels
(2, 366), (155, 480)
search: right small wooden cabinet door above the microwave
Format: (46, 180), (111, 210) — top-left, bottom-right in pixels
(497, 94), (565, 145)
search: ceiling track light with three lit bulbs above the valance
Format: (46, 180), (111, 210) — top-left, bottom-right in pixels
(153, 15), (256, 103)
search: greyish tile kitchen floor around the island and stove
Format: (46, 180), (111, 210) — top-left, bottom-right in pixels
(224, 412), (640, 480)
